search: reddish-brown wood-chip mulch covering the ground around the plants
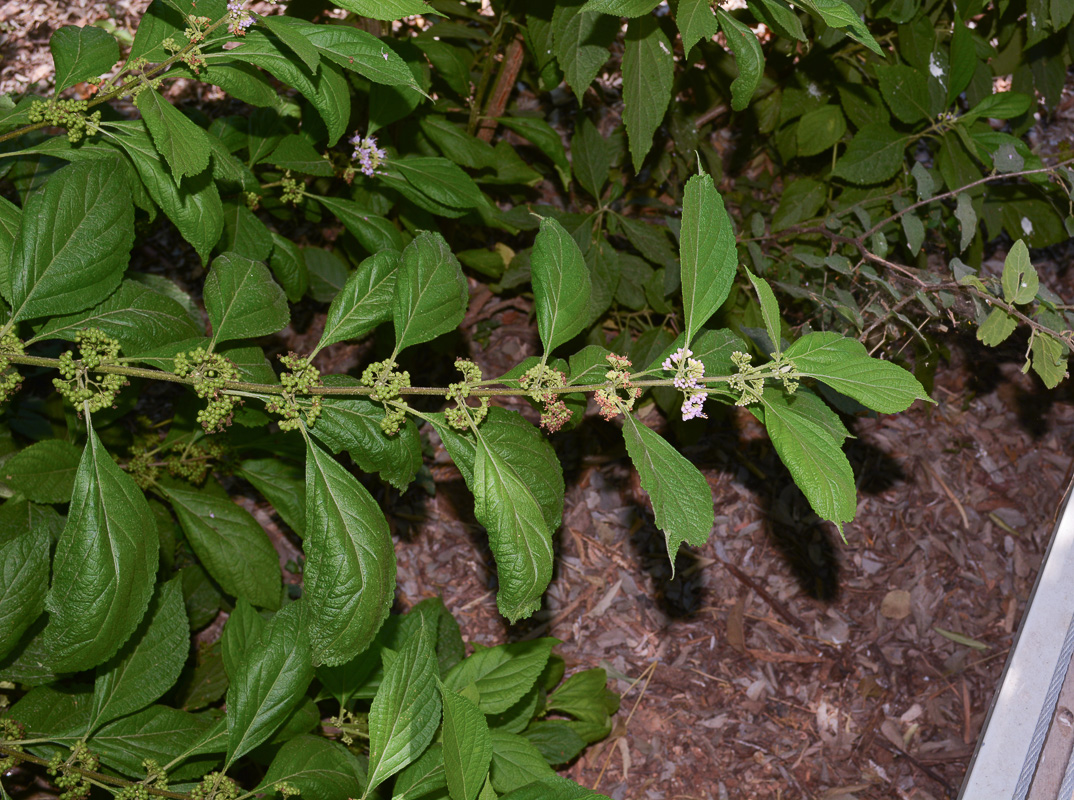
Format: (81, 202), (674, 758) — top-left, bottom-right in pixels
(6, 6), (1074, 800)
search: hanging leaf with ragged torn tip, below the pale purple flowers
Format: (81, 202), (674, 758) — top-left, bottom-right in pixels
(623, 414), (715, 577)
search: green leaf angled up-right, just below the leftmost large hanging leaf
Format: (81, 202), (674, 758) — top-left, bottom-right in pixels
(86, 577), (190, 733)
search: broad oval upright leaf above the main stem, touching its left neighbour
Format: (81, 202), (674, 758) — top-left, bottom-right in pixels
(392, 231), (469, 352)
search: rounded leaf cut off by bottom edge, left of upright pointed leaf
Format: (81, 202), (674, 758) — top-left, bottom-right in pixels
(255, 734), (365, 800)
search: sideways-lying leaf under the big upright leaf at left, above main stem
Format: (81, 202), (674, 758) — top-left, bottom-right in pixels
(33, 279), (203, 355)
